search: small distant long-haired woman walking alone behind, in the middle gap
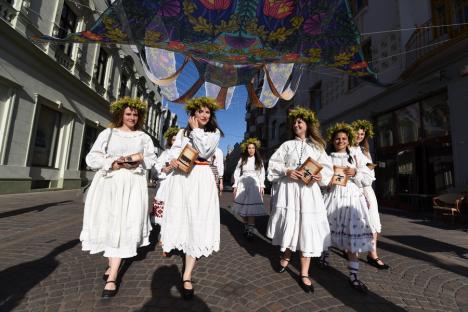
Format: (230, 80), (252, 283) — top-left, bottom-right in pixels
(232, 138), (266, 240)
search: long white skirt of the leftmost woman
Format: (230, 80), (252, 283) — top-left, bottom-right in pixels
(80, 169), (151, 258)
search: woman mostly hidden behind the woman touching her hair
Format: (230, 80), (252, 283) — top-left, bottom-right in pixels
(151, 127), (180, 225)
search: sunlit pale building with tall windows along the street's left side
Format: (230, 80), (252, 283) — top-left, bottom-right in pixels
(0, 0), (177, 193)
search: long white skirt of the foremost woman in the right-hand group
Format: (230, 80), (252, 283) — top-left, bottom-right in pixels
(267, 177), (331, 257)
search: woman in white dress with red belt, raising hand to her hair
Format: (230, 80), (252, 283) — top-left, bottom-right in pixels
(161, 97), (222, 299)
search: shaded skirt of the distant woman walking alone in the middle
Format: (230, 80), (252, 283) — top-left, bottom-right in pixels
(232, 175), (266, 217)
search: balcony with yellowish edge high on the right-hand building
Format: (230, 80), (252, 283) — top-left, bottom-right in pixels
(405, 19), (468, 72)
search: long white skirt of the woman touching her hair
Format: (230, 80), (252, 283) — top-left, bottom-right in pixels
(161, 165), (220, 258)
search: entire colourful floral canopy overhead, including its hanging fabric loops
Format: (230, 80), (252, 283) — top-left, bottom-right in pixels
(37, 0), (372, 106)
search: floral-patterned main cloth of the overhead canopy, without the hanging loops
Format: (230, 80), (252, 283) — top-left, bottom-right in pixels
(39, 0), (372, 76)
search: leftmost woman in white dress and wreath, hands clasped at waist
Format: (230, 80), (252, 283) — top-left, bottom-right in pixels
(80, 97), (156, 298)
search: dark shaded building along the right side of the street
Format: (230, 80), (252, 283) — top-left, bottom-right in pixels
(246, 0), (468, 210)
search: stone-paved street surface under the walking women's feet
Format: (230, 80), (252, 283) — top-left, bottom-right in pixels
(0, 191), (468, 312)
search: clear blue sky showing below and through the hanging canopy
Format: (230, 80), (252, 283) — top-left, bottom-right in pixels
(163, 58), (247, 155)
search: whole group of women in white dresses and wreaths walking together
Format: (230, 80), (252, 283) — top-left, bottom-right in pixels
(80, 97), (389, 300)
